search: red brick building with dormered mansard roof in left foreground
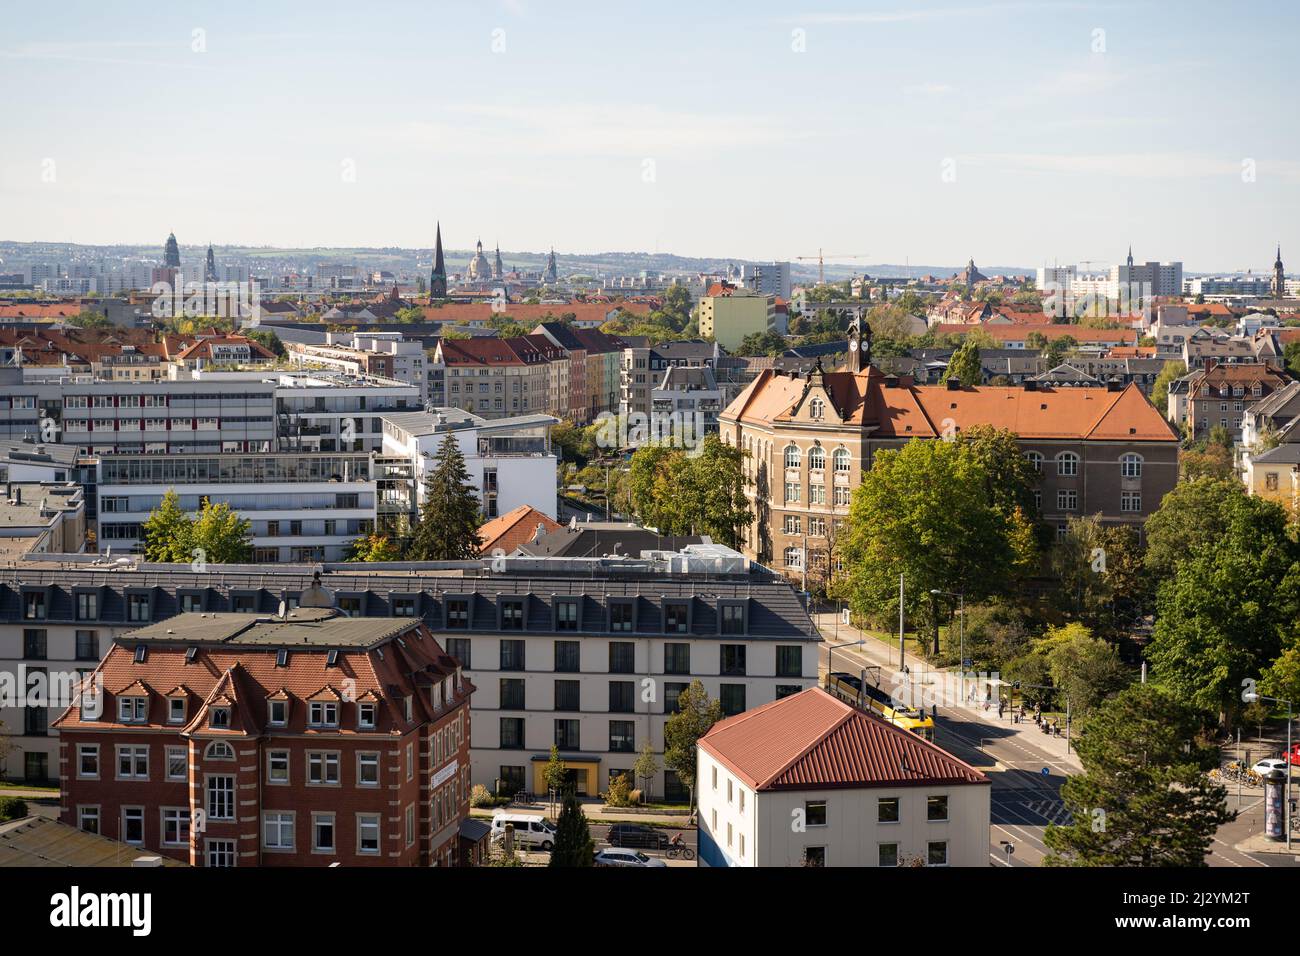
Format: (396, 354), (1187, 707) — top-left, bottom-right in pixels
(55, 598), (478, 866)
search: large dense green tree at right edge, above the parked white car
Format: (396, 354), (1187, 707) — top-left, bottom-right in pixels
(1147, 496), (1300, 724)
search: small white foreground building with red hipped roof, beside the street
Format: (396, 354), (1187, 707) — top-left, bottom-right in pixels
(696, 687), (991, 866)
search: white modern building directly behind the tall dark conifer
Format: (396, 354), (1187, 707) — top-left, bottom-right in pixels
(382, 407), (559, 520)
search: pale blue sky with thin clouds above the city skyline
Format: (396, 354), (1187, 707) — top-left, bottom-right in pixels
(0, 0), (1300, 272)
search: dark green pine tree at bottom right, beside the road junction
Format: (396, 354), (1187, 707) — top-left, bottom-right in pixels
(1044, 684), (1232, 866)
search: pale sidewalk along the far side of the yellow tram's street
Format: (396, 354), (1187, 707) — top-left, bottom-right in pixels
(813, 613), (1083, 771)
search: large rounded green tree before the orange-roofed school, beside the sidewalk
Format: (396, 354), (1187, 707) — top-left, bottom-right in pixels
(841, 438), (1037, 642)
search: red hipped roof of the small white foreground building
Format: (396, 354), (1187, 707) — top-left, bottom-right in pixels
(699, 687), (989, 791)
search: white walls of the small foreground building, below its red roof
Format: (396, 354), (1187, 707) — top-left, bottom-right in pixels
(697, 748), (989, 866)
